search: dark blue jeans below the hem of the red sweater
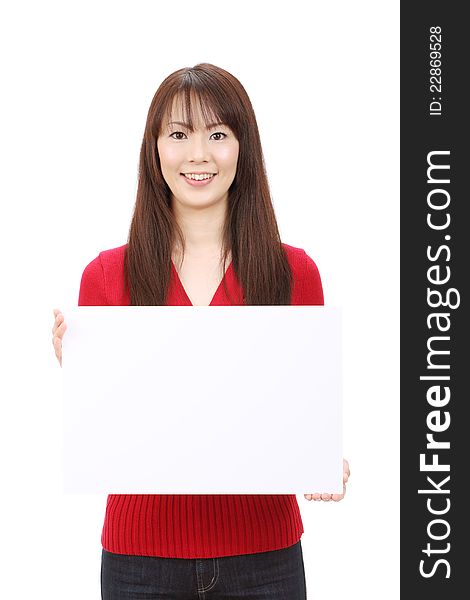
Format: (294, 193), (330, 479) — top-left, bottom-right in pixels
(101, 540), (307, 600)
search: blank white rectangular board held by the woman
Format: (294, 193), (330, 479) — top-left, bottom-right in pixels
(62, 306), (343, 494)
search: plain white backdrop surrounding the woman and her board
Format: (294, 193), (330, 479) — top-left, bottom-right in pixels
(0, 0), (399, 600)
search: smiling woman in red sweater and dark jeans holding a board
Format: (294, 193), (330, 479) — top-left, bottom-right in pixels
(52, 63), (349, 600)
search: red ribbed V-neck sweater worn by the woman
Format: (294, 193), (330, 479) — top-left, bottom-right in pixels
(78, 244), (323, 558)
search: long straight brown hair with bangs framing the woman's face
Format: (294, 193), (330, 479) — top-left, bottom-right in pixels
(124, 63), (292, 306)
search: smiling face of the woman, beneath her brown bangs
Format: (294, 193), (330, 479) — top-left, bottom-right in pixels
(157, 98), (239, 208)
